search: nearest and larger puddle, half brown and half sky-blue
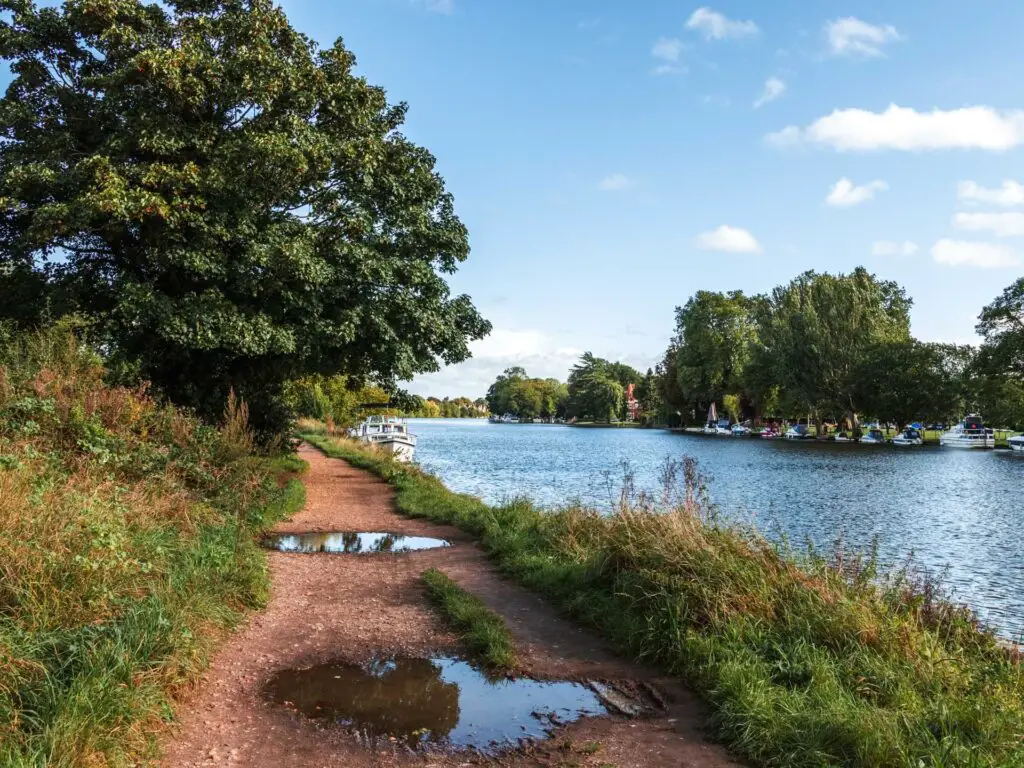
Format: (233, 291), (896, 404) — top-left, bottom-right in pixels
(266, 657), (607, 751)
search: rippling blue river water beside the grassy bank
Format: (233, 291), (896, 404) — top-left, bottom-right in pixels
(412, 419), (1024, 638)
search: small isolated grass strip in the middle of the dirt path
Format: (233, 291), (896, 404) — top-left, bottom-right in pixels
(423, 568), (518, 672)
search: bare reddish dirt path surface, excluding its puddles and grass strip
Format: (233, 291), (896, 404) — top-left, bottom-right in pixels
(163, 446), (737, 768)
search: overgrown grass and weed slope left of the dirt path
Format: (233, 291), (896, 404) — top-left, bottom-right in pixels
(0, 332), (304, 768)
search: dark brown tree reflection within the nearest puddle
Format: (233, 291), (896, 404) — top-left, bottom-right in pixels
(267, 658), (459, 744)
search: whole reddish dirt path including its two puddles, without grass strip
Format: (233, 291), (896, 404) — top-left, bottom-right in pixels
(162, 445), (738, 768)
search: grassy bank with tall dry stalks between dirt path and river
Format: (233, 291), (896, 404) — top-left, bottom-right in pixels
(310, 435), (1024, 768)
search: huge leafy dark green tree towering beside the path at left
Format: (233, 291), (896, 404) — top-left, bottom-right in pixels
(0, 0), (489, 436)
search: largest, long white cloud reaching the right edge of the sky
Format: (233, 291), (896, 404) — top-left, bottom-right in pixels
(766, 104), (1024, 152)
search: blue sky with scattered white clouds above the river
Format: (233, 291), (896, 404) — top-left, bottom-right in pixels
(97, 0), (1024, 396)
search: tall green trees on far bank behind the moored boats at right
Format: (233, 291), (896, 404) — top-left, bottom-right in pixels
(656, 268), (1024, 428)
